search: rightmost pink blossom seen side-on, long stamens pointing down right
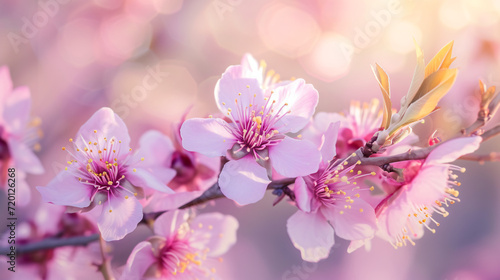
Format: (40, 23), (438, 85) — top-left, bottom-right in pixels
(376, 136), (481, 248)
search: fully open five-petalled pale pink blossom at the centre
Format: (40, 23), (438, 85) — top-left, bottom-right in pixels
(181, 57), (320, 205)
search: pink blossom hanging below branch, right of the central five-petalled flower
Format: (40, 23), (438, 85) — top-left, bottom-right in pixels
(287, 123), (376, 262)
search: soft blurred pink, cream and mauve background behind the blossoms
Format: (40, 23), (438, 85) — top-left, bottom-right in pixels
(0, 0), (500, 280)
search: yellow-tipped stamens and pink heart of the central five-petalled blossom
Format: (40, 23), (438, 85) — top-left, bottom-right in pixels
(227, 88), (290, 158)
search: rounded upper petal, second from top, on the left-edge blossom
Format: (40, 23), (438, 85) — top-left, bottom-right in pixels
(3, 87), (31, 137)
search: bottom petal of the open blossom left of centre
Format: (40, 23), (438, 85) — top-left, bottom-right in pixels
(97, 190), (142, 241)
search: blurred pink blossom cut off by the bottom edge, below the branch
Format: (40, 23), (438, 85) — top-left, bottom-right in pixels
(120, 210), (238, 280)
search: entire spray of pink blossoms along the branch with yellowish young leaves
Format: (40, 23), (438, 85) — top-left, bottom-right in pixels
(0, 40), (494, 279)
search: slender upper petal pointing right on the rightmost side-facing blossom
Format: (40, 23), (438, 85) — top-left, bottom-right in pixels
(425, 136), (482, 164)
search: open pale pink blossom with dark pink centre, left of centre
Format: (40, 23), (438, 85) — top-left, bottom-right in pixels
(37, 108), (172, 241)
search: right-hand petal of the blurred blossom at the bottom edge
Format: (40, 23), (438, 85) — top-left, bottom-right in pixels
(191, 213), (239, 257)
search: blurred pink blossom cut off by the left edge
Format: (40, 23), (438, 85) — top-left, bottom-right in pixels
(0, 67), (44, 205)
